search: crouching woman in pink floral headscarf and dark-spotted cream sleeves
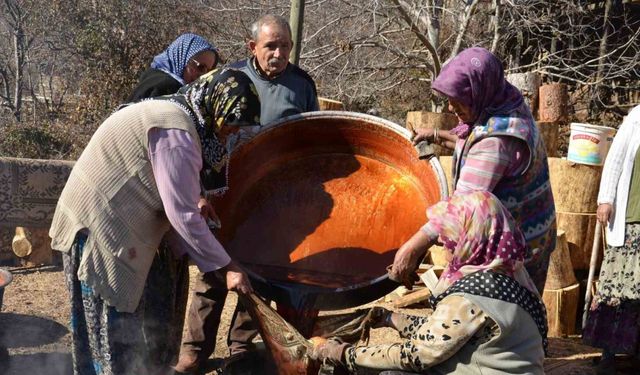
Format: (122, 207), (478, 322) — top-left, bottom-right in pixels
(311, 192), (547, 375)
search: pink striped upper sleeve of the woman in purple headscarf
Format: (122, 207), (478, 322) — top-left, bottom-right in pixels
(455, 137), (527, 192)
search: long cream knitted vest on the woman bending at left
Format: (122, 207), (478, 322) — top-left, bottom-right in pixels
(49, 100), (200, 312)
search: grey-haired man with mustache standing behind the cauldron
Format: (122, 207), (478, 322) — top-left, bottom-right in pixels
(175, 14), (319, 373)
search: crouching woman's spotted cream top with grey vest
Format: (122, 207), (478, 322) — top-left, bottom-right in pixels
(345, 293), (544, 375)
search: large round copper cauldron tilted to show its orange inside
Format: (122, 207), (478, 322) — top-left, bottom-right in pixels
(216, 111), (448, 310)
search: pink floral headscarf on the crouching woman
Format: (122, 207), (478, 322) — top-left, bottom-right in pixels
(427, 191), (538, 295)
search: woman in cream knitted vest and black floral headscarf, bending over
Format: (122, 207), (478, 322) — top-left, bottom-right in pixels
(49, 70), (260, 375)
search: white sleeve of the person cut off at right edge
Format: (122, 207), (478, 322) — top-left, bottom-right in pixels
(598, 122), (633, 204)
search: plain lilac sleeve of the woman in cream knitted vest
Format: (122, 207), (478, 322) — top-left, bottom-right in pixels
(149, 129), (231, 272)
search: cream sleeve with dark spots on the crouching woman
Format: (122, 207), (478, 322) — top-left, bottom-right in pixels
(344, 295), (494, 372)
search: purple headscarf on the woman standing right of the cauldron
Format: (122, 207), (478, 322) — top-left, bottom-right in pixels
(431, 47), (524, 138)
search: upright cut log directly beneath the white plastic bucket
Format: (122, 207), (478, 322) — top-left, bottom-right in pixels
(548, 158), (602, 213)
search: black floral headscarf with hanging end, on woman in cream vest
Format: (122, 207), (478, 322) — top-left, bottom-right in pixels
(168, 68), (260, 194)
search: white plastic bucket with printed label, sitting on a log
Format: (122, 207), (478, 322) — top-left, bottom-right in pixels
(567, 123), (616, 165)
